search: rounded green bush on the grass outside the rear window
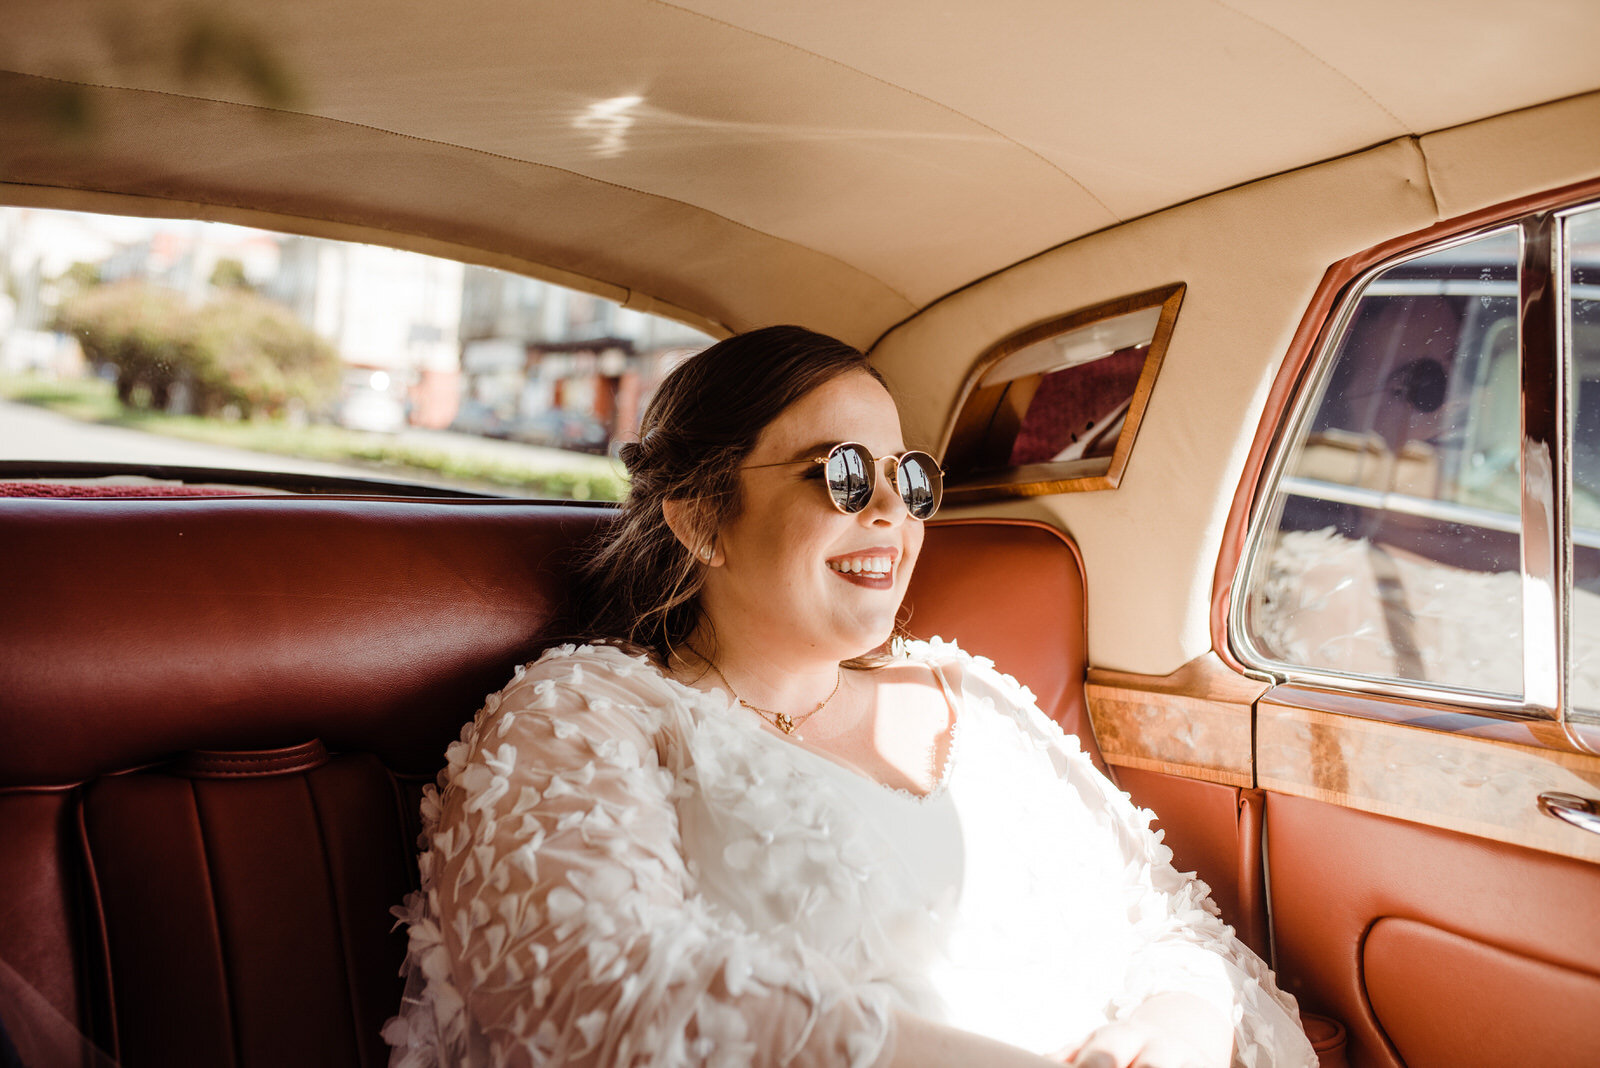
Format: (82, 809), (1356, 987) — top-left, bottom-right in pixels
(58, 281), (339, 417)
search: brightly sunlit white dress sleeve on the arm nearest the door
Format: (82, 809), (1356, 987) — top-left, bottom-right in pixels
(936, 646), (1317, 1068)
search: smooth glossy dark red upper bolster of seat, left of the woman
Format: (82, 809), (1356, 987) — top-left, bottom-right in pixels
(0, 499), (608, 787)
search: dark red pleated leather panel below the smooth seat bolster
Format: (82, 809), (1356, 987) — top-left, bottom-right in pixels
(82, 743), (414, 1068)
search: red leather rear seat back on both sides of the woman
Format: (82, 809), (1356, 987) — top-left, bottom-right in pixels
(0, 499), (1094, 1066)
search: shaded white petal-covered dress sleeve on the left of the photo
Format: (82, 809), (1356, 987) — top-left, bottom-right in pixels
(386, 646), (891, 1066)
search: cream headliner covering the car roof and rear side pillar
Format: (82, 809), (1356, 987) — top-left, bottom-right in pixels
(0, 0), (1600, 675)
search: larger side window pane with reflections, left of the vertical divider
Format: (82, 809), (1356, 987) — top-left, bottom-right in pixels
(1242, 229), (1523, 695)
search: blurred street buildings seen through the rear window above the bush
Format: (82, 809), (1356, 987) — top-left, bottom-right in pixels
(0, 208), (710, 451)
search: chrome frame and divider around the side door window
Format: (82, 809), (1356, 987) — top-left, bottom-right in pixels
(1227, 200), (1600, 724)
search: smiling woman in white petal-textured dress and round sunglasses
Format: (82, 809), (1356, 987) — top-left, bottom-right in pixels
(384, 326), (1315, 1068)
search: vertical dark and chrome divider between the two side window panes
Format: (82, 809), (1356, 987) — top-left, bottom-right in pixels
(1517, 213), (1571, 718)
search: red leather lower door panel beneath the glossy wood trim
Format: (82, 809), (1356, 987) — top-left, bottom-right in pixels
(1267, 793), (1600, 1068)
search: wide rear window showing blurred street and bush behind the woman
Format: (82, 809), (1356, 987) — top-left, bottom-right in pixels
(0, 208), (710, 500)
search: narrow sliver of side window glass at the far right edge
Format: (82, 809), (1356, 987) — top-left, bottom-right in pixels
(1566, 208), (1600, 718)
